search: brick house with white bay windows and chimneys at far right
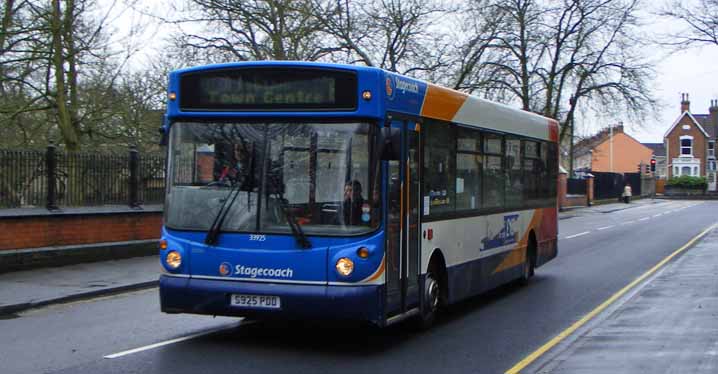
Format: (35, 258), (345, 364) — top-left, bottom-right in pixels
(663, 94), (718, 191)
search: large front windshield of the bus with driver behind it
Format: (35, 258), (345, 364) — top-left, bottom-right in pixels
(165, 122), (381, 235)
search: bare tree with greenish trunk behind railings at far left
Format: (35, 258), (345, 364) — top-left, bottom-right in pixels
(0, 0), (139, 151)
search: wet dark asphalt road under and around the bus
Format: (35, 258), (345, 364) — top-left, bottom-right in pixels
(0, 201), (718, 374)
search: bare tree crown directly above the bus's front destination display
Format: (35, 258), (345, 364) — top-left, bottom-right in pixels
(167, 0), (331, 62)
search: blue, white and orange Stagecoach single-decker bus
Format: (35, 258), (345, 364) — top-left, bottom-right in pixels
(160, 61), (558, 326)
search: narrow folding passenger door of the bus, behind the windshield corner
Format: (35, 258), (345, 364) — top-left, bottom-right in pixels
(386, 121), (421, 317)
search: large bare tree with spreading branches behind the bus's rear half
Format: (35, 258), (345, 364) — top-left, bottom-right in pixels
(458, 0), (655, 172)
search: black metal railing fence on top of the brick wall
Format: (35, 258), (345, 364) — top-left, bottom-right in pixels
(0, 146), (165, 209)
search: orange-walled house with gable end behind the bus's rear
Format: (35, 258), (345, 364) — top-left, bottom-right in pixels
(574, 125), (653, 173)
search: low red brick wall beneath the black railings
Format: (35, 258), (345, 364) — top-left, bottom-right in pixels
(0, 212), (162, 251)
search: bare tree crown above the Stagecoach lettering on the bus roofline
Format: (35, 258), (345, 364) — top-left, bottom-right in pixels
(312, 0), (452, 77)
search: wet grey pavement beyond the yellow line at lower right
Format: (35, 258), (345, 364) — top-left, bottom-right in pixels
(523, 225), (718, 374)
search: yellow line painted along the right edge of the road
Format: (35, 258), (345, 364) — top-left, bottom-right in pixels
(505, 223), (718, 374)
